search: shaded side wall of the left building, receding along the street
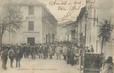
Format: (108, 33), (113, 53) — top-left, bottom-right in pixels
(42, 8), (57, 43)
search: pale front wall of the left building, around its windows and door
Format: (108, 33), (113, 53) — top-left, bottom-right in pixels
(3, 6), (42, 44)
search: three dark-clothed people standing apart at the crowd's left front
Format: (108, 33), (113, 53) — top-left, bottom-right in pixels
(0, 45), (23, 70)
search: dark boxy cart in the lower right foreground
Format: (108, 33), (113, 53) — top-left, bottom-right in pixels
(83, 52), (102, 73)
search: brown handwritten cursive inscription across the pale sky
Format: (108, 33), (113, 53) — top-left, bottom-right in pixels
(49, 0), (95, 21)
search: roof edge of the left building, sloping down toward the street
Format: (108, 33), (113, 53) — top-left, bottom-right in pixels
(1, 0), (57, 22)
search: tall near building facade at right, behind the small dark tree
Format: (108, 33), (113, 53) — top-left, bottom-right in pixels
(76, 0), (114, 59)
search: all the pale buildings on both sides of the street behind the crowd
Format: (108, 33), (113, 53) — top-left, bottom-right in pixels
(2, 0), (114, 59)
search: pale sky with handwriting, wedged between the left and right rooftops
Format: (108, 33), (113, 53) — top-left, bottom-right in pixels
(38, 0), (85, 23)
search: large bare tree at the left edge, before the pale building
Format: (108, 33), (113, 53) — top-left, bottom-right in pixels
(0, 4), (23, 46)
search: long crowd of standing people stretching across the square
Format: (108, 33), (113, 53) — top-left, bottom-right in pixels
(0, 43), (79, 70)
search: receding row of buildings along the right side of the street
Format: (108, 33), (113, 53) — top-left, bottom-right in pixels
(58, 0), (114, 58)
